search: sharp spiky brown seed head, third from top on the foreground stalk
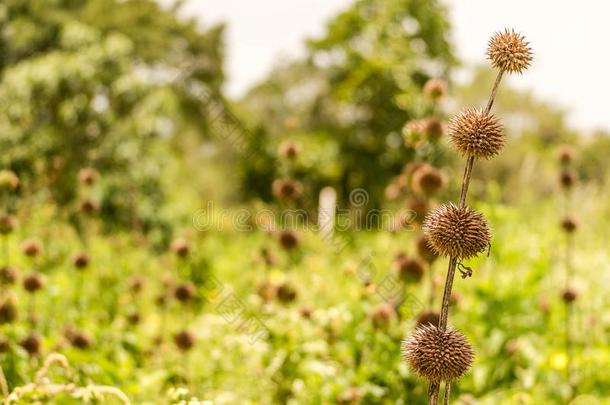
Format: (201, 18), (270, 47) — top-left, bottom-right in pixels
(423, 203), (491, 259)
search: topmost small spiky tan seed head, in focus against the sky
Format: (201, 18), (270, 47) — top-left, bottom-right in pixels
(487, 29), (533, 73)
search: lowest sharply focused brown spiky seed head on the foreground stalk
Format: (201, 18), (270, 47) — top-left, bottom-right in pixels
(402, 325), (474, 382)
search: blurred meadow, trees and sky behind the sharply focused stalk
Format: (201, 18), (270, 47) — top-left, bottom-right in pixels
(0, 0), (610, 404)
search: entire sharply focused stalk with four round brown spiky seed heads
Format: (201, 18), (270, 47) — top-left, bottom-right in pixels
(402, 30), (528, 404)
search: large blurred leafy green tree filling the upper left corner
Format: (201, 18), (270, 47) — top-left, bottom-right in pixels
(0, 0), (224, 240)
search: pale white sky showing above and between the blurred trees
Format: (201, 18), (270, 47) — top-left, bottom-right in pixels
(169, 0), (610, 131)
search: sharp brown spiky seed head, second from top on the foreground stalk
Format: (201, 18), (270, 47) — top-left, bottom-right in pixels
(449, 108), (504, 159)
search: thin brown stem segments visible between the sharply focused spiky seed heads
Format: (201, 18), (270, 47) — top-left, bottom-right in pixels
(428, 70), (504, 405)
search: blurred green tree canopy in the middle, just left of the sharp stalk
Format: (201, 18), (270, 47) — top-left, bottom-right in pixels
(242, 0), (454, 206)
